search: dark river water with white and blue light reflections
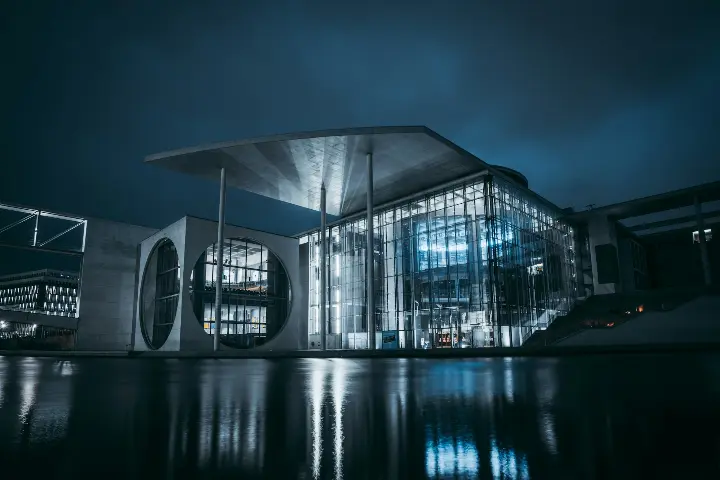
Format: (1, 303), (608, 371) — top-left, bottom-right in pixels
(0, 354), (720, 479)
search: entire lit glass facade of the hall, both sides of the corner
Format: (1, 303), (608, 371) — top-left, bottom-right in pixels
(301, 176), (577, 349)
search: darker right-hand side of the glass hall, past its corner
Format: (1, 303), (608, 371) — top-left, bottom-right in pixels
(487, 178), (577, 346)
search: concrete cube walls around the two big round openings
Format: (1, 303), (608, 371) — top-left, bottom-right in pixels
(134, 217), (307, 351)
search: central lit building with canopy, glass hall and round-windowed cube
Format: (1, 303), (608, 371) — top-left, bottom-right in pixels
(141, 127), (577, 350)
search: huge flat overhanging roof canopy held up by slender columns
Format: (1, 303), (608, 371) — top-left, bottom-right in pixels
(145, 126), (492, 216)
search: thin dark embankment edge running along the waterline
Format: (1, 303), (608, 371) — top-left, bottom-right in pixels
(0, 343), (720, 359)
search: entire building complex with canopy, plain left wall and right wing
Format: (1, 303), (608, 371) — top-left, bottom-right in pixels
(0, 127), (720, 352)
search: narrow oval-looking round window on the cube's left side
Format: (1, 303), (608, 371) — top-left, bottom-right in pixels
(140, 238), (180, 349)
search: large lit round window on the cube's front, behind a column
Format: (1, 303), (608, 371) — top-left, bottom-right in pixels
(190, 238), (290, 348)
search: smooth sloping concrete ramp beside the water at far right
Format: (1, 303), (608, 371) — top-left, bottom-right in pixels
(555, 295), (720, 346)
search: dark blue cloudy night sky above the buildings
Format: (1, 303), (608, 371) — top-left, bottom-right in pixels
(0, 0), (720, 234)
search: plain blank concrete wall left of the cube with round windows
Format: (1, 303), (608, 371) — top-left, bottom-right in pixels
(77, 219), (156, 350)
